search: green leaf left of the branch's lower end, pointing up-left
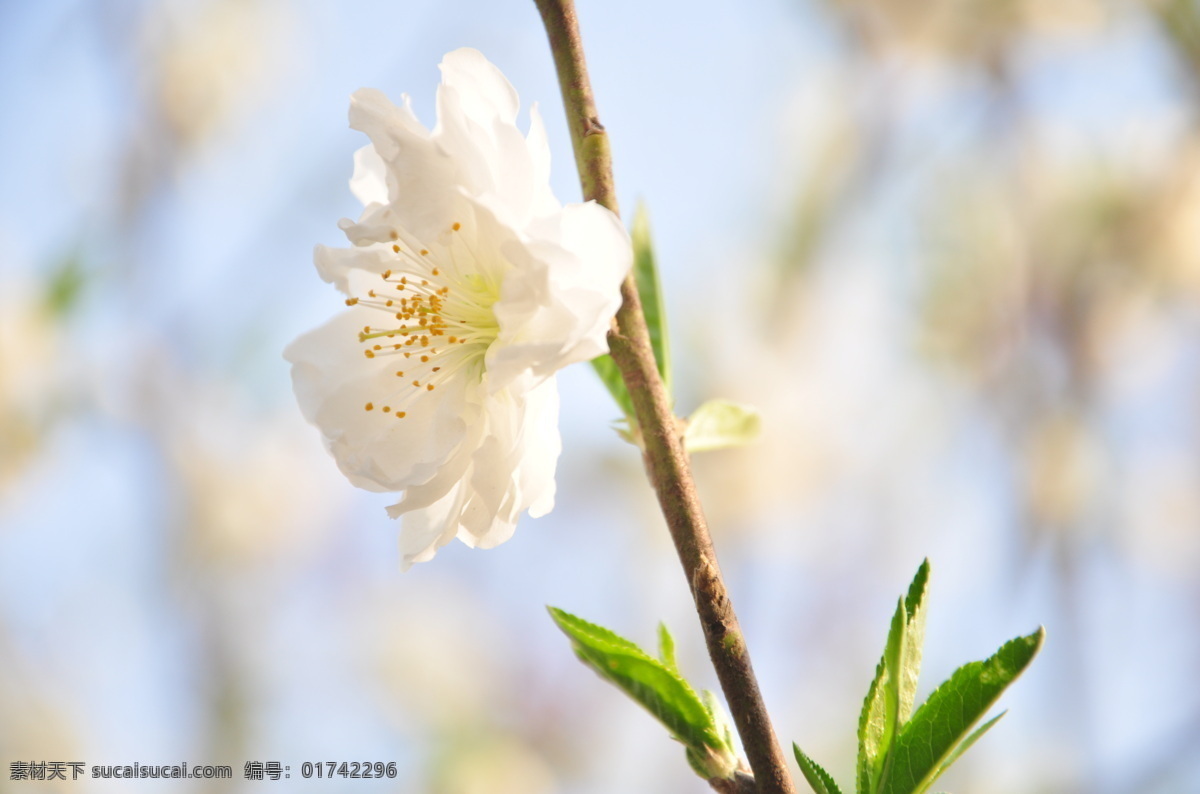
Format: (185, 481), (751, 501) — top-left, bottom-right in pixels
(548, 607), (737, 777)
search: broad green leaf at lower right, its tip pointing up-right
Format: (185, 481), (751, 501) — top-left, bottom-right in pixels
(880, 628), (1045, 794)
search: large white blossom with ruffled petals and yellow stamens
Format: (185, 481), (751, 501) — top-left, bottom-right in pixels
(284, 49), (632, 569)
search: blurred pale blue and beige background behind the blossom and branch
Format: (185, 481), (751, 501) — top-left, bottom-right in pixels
(0, 0), (1200, 794)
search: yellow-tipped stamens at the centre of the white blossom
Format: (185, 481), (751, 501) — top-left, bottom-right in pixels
(346, 222), (499, 419)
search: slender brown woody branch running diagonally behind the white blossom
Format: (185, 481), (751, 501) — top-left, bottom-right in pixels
(534, 0), (796, 794)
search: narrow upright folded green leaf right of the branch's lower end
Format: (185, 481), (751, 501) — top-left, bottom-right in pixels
(856, 560), (929, 794)
